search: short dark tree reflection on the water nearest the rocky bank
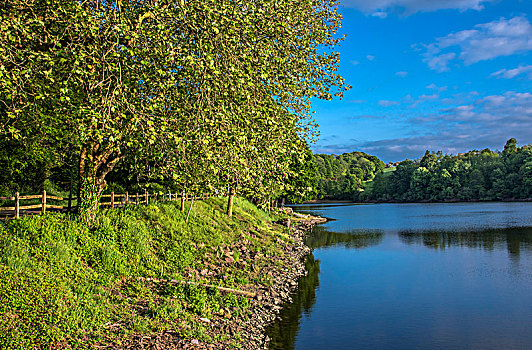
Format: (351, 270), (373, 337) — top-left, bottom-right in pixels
(305, 226), (384, 248)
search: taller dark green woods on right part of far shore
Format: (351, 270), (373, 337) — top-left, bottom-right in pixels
(366, 138), (532, 201)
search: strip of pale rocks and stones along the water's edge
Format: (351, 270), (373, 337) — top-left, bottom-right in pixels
(117, 211), (327, 350)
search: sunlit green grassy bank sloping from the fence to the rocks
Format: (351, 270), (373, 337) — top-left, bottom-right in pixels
(0, 198), (289, 349)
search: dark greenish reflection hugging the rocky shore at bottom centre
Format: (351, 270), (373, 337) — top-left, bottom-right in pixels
(266, 255), (320, 350)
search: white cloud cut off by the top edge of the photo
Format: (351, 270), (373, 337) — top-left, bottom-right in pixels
(342, 0), (493, 18)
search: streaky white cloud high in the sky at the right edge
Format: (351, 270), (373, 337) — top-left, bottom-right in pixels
(423, 17), (532, 72)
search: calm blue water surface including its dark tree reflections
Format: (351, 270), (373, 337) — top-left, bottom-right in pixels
(267, 203), (532, 350)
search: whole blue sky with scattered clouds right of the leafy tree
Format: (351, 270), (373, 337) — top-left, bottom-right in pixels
(312, 0), (532, 162)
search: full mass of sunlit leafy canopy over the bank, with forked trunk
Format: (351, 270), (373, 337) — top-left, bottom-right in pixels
(0, 0), (348, 218)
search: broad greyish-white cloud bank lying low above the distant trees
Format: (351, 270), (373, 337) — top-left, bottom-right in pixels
(313, 91), (532, 162)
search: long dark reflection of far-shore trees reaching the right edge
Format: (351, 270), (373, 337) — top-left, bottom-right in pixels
(399, 227), (532, 259)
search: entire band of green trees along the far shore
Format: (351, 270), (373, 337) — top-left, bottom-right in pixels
(314, 138), (532, 202)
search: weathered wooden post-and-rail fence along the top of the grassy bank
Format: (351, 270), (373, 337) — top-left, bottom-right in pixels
(0, 191), (201, 219)
